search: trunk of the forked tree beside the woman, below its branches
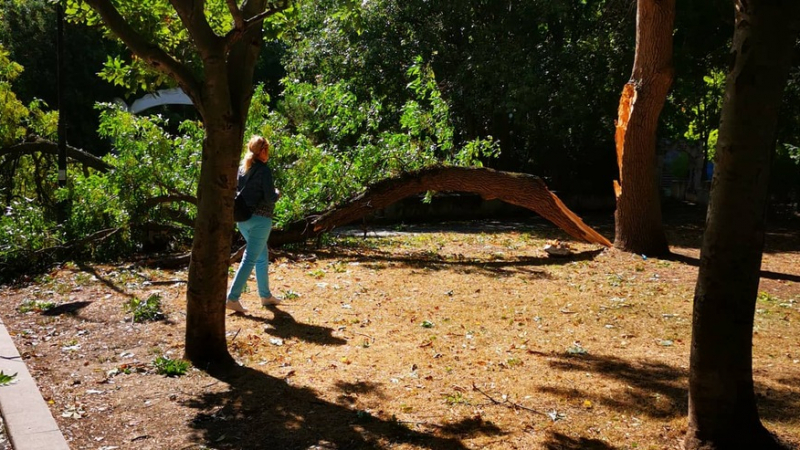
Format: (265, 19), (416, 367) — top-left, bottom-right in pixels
(185, 121), (243, 370)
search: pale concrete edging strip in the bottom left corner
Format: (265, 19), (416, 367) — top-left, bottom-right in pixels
(0, 318), (69, 450)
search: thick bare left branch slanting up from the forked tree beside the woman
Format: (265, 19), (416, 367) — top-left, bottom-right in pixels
(86, 0), (202, 103)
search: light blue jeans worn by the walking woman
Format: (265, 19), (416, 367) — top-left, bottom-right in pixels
(228, 215), (272, 300)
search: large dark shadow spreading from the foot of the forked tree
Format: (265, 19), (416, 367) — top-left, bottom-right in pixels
(187, 367), (476, 450)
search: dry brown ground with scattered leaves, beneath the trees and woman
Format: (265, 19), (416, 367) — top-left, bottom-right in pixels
(0, 206), (800, 450)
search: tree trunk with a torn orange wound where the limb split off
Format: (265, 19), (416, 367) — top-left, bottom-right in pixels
(614, 0), (675, 255)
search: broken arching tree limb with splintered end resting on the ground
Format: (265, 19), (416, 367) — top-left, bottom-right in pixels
(269, 167), (611, 247)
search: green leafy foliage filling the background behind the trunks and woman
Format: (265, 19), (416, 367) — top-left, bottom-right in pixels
(0, 0), (800, 282)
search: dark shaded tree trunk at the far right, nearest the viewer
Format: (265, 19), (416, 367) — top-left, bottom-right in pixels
(685, 0), (800, 450)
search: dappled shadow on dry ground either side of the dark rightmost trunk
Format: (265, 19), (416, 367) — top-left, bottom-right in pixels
(539, 354), (800, 422)
